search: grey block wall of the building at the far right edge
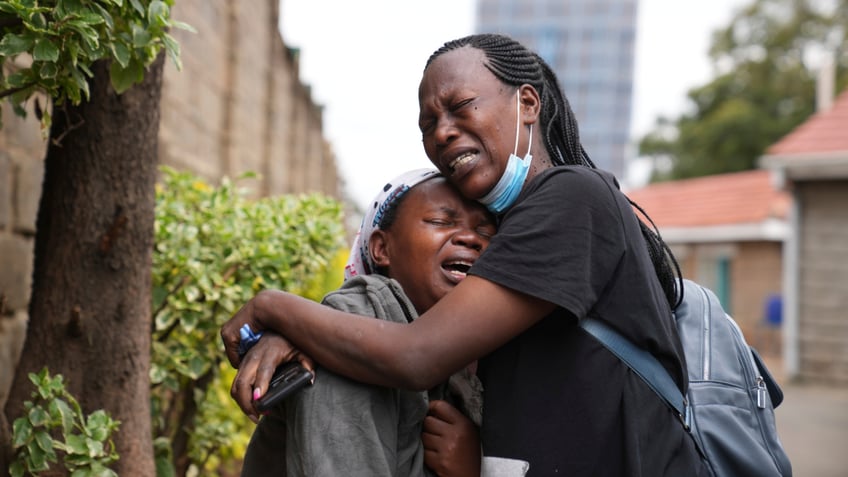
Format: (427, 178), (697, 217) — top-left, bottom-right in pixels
(796, 180), (848, 385)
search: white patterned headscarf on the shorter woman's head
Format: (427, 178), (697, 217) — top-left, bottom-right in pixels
(345, 169), (440, 280)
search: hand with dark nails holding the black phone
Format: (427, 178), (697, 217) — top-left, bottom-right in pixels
(229, 331), (315, 422)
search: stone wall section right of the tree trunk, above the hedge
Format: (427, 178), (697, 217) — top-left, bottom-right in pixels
(160, 0), (341, 198)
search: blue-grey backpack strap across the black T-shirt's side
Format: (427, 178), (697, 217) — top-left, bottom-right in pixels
(580, 318), (690, 430)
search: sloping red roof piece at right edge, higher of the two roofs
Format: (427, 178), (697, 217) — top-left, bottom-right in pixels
(766, 90), (848, 155)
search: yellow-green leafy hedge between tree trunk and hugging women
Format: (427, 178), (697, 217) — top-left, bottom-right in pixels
(150, 167), (344, 476)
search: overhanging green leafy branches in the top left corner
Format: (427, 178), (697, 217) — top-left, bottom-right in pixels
(0, 0), (195, 132)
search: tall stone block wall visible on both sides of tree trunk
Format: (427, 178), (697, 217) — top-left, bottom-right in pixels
(0, 0), (342, 409)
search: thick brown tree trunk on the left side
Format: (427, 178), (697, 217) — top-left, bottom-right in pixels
(5, 55), (164, 476)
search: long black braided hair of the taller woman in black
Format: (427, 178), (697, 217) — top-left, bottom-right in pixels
(424, 33), (683, 309)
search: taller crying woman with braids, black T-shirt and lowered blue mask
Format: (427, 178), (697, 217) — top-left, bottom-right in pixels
(221, 34), (707, 477)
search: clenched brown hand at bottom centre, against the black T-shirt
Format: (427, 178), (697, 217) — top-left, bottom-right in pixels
(421, 401), (480, 477)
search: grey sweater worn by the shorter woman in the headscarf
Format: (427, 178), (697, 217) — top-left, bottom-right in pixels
(242, 275), (482, 477)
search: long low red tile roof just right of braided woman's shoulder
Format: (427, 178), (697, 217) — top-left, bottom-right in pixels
(627, 169), (790, 229)
